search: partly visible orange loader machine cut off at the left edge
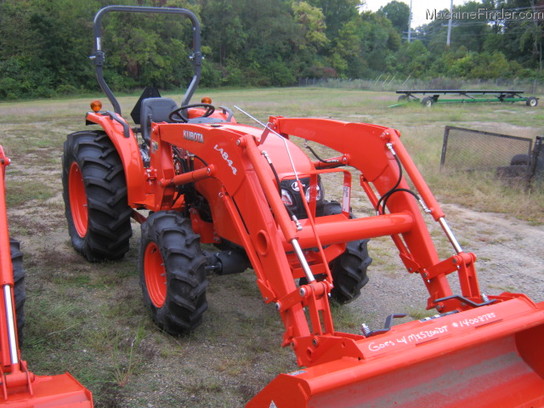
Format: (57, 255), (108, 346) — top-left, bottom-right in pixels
(0, 146), (93, 408)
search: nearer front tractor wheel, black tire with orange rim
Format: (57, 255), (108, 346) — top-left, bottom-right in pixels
(139, 211), (208, 335)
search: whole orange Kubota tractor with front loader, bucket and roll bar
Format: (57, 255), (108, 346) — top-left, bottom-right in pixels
(63, 6), (544, 408)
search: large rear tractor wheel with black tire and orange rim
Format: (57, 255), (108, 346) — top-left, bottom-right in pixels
(62, 131), (132, 262)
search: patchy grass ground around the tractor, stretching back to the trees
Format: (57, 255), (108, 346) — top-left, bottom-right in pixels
(0, 88), (544, 408)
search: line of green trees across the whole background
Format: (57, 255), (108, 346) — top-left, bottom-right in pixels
(0, 0), (544, 100)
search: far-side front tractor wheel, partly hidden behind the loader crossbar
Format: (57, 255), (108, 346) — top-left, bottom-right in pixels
(319, 201), (372, 304)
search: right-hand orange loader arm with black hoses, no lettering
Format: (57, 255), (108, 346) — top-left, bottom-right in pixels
(270, 117), (482, 312)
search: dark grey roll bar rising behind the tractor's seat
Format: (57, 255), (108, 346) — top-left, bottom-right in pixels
(90, 6), (202, 115)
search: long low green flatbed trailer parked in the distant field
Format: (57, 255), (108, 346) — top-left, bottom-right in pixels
(393, 89), (538, 108)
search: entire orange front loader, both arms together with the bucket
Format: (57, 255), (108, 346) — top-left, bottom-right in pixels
(151, 117), (544, 408)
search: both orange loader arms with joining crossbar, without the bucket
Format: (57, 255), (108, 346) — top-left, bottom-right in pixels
(151, 118), (482, 365)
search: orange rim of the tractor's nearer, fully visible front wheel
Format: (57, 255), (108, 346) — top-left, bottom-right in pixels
(144, 242), (166, 308)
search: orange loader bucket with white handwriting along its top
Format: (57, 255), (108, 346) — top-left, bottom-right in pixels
(247, 295), (544, 408)
